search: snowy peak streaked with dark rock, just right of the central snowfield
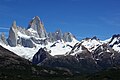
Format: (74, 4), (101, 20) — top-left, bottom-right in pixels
(70, 38), (103, 55)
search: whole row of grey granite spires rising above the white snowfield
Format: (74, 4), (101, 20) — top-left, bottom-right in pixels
(4, 16), (75, 48)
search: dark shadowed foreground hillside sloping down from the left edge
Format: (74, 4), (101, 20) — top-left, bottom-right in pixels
(0, 46), (72, 80)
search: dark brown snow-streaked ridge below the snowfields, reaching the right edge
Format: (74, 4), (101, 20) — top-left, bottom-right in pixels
(32, 39), (120, 73)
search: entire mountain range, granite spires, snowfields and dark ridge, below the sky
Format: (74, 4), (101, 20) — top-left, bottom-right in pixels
(0, 16), (120, 74)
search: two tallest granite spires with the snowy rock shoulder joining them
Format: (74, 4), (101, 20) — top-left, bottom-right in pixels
(7, 16), (47, 48)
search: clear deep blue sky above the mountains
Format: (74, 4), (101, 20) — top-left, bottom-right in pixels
(0, 0), (120, 39)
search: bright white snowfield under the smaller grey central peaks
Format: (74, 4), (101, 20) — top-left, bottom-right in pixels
(46, 39), (78, 56)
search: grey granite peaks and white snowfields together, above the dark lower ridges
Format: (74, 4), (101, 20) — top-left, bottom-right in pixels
(0, 16), (120, 60)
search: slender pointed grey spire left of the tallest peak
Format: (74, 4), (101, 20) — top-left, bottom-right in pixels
(7, 21), (18, 47)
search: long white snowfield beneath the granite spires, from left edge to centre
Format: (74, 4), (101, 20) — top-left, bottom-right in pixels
(0, 39), (78, 60)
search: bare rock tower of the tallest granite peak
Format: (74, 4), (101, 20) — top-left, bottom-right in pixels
(28, 16), (47, 38)
